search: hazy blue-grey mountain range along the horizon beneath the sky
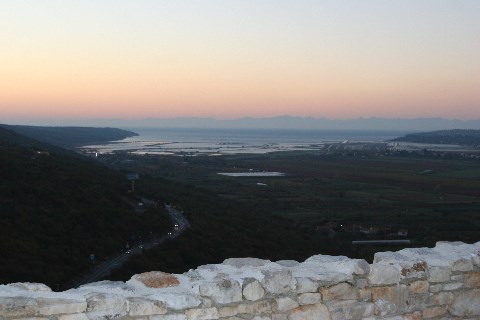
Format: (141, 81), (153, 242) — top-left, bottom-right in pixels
(4, 116), (480, 132)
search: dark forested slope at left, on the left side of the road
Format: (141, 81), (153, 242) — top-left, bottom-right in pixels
(0, 128), (170, 288)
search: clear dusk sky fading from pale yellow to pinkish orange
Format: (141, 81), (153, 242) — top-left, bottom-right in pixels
(0, 0), (480, 122)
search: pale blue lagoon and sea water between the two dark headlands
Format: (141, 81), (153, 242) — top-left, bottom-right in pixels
(82, 128), (405, 156)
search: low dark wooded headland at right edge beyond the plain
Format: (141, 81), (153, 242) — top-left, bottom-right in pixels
(392, 129), (480, 147)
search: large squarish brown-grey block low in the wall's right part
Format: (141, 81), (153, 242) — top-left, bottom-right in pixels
(372, 285), (408, 317)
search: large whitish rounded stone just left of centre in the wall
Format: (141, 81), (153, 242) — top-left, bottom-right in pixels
(199, 279), (242, 304)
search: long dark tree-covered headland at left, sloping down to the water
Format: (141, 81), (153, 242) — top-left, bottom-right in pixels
(0, 124), (137, 148)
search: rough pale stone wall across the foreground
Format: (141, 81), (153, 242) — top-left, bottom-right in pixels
(0, 242), (480, 320)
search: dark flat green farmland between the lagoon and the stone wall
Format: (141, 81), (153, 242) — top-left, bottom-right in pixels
(104, 152), (480, 278)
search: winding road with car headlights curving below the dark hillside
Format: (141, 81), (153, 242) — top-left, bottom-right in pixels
(69, 205), (190, 288)
